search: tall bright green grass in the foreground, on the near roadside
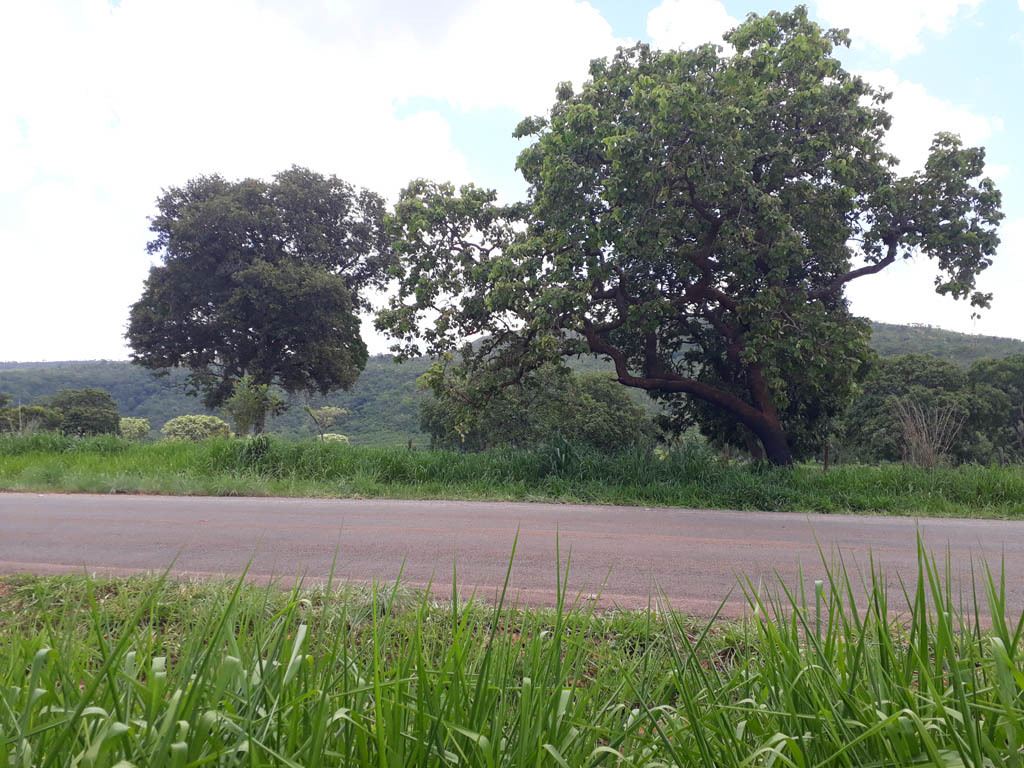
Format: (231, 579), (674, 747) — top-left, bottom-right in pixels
(0, 540), (1024, 768)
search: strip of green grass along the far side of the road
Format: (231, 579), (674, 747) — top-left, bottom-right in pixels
(0, 435), (1024, 518)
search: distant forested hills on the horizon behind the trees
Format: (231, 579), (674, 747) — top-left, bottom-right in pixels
(0, 323), (1024, 445)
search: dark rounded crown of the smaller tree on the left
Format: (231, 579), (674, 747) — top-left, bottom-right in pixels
(127, 167), (391, 408)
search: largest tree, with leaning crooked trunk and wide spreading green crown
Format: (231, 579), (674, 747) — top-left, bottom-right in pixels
(378, 6), (1001, 464)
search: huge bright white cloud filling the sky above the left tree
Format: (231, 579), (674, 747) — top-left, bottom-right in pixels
(0, 0), (625, 359)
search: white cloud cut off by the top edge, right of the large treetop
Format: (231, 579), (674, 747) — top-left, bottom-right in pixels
(817, 0), (983, 59)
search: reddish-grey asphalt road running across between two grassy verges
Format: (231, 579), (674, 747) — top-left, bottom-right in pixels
(0, 494), (1024, 615)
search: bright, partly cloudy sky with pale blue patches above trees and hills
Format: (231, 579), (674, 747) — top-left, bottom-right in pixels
(0, 0), (1024, 360)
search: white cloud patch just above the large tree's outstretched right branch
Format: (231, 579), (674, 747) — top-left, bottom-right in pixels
(857, 70), (1002, 173)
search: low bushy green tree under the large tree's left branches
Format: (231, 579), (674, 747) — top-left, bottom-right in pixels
(420, 364), (656, 453)
